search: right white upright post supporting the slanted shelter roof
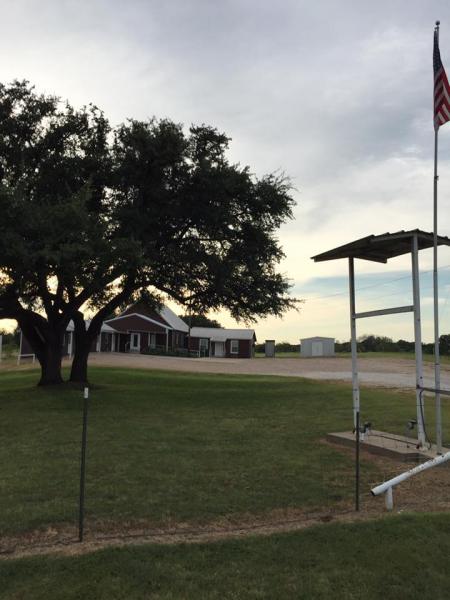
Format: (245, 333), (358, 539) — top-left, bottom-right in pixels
(411, 235), (425, 447)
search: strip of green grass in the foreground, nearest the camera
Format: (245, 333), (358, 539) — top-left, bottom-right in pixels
(0, 515), (450, 600)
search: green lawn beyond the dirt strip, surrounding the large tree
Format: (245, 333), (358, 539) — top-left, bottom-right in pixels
(0, 368), (450, 533)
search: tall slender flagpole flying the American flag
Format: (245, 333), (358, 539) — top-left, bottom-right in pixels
(433, 21), (442, 454)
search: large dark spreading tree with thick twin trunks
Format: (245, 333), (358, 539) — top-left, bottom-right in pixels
(0, 81), (296, 383)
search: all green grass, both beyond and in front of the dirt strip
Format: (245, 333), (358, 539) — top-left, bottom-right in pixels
(0, 368), (450, 600)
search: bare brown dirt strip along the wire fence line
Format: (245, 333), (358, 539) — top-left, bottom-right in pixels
(0, 441), (450, 559)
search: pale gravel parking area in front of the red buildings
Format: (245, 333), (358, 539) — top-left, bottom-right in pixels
(89, 353), (450, 388)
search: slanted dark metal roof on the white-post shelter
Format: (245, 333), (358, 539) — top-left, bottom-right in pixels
(311, 229), (450, 263)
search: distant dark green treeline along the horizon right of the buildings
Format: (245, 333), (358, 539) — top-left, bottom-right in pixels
(255, 334), (450, 355)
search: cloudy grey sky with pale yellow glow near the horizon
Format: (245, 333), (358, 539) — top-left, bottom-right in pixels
(0, 0), (450, 342)
